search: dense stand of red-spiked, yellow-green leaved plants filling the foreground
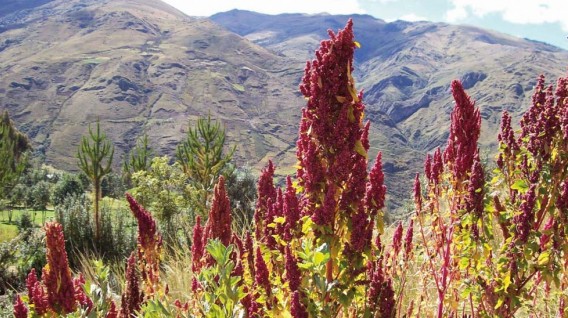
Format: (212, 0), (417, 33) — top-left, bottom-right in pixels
(1, 20), (568, 318)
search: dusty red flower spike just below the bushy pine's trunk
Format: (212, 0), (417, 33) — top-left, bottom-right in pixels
(205, 176), (231, 246)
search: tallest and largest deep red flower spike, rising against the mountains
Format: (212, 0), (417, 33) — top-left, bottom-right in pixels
(296, 20), (368, 232)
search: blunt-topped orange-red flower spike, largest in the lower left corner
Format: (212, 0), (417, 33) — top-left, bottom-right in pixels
(42, 222), (77, 314)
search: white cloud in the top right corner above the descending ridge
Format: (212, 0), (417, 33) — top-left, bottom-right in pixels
(446, 0), (568, 31)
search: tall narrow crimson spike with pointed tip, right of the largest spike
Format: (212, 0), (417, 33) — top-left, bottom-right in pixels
(444, 80), (481, 183)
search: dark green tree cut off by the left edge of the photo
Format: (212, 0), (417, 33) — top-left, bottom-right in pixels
(0, 111), (31, 200)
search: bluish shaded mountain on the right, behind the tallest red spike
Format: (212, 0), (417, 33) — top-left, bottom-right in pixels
(211, 10), (568, 211)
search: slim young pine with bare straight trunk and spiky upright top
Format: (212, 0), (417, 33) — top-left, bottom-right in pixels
(77, 121), (114, 240)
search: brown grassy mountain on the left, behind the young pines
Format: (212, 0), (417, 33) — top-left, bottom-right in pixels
(0, 0), (303, 175)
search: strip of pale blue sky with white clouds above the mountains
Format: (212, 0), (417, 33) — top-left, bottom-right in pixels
(164, 0), (568, 49)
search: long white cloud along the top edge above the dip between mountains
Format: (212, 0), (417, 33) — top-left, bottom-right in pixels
(163, 0), (364, 16)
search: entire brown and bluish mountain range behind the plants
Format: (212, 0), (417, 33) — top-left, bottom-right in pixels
(0, 0), (568, 212)
